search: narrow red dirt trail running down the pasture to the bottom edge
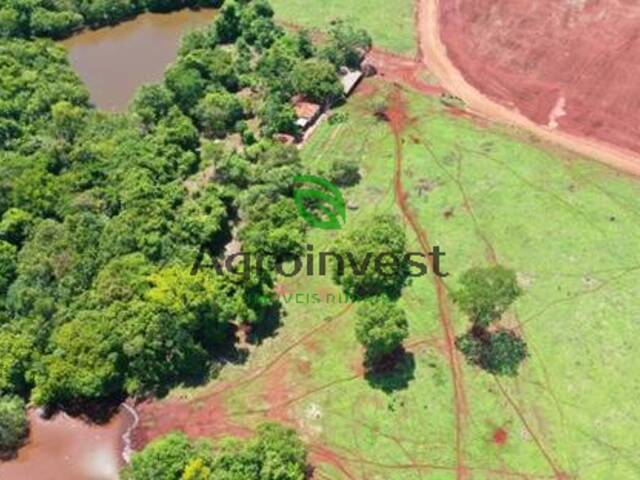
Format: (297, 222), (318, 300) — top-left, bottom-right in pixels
(387, 89), (468, 480)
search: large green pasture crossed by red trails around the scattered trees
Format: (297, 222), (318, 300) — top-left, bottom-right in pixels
(206, 80), (640, 480)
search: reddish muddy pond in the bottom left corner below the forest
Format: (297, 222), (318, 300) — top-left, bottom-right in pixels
(0, 410), (134, 480)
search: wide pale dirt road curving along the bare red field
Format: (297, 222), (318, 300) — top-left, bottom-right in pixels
(416, 0), (640, 177)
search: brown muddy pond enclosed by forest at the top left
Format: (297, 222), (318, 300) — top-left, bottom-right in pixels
(62, 10), (215, 111)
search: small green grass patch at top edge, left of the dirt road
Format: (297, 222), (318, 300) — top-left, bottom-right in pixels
(271, 0), (416, 55)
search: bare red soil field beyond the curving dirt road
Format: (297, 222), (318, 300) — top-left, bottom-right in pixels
(439, 0), (640, 153)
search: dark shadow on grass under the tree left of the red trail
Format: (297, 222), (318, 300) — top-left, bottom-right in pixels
(364, 348), (416, 394)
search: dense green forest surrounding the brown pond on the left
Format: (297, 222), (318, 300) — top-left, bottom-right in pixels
(0, 0), (371, 446)
